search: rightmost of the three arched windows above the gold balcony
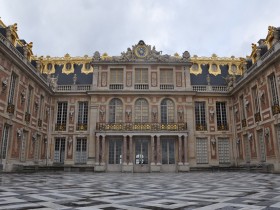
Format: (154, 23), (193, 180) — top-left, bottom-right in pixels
(160, 99), (175, 123)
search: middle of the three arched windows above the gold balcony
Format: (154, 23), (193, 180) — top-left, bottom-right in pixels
(134, 98), (149, 122)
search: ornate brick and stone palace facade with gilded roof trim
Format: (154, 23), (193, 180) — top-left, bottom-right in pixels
(0, 20), (280, 172)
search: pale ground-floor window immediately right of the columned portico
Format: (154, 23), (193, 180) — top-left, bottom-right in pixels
(196, 138), (208, 164)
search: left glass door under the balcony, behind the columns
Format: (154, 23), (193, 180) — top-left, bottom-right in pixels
(109, 137), (123, 164)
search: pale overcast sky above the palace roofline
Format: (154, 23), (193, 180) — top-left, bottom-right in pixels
(0, 0), (280, 57)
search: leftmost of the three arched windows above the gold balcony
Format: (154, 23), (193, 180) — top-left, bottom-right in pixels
(109, 98), (123, 123)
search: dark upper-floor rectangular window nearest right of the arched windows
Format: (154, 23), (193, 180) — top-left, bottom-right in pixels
(195, 102), (207, 131)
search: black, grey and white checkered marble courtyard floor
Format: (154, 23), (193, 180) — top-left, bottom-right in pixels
(0, 172), (280, 210)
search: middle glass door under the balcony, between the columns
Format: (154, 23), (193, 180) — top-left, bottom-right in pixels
(134, 137), (150, 172)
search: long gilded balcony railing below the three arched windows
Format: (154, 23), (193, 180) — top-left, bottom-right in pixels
(96, 123), (187, 131)
